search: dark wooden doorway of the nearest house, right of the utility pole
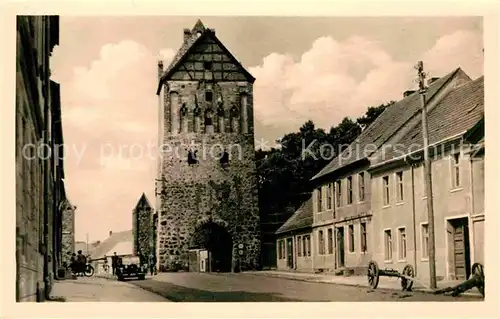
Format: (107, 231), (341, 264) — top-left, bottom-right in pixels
(446, 217), (471, 280)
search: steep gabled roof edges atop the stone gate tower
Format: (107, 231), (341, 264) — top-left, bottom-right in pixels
(157, 19), (255, 94)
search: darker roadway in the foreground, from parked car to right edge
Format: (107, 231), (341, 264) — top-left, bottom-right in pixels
(129, 273), (480, 302)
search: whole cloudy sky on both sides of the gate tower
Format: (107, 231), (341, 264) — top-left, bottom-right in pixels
(50, 16), (483, 241)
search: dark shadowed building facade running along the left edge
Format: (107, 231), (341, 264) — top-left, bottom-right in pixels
(16, 16), (66, 301)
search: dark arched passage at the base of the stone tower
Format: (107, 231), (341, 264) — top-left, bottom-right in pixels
(190, 221), (233, 272)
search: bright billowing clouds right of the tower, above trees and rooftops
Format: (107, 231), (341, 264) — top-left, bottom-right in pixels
(249, 31), (483, 134)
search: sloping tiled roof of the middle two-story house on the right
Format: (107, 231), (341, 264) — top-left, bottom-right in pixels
(312, 68), (461, 180)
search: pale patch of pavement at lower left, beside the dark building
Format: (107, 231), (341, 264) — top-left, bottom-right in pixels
(51, 277), (169, 302)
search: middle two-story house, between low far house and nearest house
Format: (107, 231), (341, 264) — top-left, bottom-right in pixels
(278, 68), (470, 272)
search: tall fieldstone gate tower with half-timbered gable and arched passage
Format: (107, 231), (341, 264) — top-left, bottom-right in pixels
(155, 20), (260, 271)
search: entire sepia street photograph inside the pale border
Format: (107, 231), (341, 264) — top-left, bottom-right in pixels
(9, 9), (495, 310)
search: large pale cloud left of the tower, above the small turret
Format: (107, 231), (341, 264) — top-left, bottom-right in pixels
(52, 40), (175, 239)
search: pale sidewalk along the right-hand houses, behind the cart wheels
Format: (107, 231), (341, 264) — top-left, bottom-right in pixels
(242, 270), (483, 299)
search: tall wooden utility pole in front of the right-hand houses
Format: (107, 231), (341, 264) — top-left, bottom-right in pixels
(415, 61), (437, 289)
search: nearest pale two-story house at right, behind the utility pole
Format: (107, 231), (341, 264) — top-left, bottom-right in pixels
(369, 77), (484, 281)
